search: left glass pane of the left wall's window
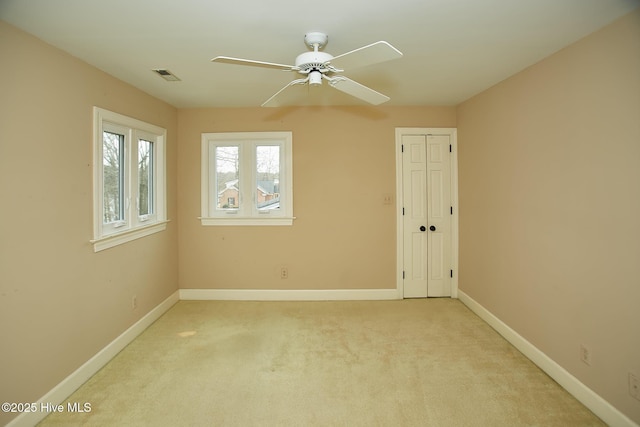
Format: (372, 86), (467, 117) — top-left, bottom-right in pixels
(102, 132), (124, 224)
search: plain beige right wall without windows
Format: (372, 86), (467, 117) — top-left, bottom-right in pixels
(457, 11), (640, 422)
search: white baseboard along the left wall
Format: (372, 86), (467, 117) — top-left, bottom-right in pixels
(6, 291), (179, 427)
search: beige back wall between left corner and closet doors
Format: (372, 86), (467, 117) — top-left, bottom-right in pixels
(178, 107), (456, 289)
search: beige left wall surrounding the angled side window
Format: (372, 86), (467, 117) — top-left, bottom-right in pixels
(0, 21), (178, 425)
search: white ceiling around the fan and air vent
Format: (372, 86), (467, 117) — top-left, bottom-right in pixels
(0, 0), (640, 108)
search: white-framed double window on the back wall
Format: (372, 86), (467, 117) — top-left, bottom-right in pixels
(200, 132), (294, 225)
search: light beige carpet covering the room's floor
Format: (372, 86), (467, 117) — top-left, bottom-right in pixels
(40, 299), (605, 427)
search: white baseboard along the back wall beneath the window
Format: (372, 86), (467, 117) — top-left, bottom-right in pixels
(179, 289), (400, 301)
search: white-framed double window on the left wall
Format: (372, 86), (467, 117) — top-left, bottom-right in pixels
(91, 107), (167, 252)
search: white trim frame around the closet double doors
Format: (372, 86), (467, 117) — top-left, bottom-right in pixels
(395, 127), (459, 299)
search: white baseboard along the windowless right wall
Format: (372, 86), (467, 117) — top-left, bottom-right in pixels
(458, 289), (639, 427)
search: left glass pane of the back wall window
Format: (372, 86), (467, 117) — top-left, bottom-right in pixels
(215, 145), (240, 210)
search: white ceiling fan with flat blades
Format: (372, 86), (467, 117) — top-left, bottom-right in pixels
(211, 32), (402, 107)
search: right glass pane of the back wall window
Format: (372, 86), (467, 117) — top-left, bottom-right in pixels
(256, 145), (280, 211)
